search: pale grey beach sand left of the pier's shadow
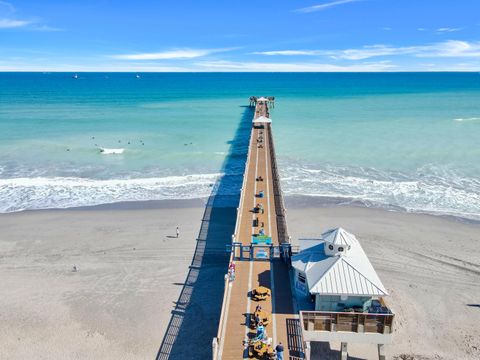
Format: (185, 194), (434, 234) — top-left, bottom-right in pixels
(0, 200), (210, 359)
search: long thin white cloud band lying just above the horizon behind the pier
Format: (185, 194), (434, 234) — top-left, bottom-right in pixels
(195, 61), (395, 72)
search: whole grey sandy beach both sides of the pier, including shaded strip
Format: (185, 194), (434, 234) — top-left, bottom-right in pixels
(0, 199), (480, 359)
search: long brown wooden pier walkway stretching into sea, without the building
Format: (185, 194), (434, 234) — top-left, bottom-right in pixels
(213, 98), (302, 360)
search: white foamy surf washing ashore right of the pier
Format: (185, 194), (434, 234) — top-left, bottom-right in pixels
(280, 166), (480, 220)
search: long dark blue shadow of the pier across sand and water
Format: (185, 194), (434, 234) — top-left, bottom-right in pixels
(156, 106), (254, 360)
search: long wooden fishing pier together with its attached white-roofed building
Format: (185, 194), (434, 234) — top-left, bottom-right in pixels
(212, 96), (394, 360)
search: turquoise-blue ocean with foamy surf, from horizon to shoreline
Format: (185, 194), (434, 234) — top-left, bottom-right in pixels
(0, 73), (480, 219)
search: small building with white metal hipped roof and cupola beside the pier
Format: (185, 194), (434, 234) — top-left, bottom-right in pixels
(292, 228), (394, 359)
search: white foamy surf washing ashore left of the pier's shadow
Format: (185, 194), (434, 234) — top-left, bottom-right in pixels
(0, 174), (225, 212)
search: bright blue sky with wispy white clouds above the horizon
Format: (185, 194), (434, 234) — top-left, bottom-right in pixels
(0, 0), (480, 72)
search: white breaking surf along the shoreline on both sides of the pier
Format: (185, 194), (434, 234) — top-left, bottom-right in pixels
(0, 161), (480, 220)
